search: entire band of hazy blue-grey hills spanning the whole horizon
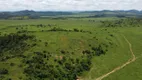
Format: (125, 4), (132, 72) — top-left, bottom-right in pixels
(0, 10), (142, 19)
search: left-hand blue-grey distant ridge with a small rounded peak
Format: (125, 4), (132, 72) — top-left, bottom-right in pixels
(0, 10), (72, 19)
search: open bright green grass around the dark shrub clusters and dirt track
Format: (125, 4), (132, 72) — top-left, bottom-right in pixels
(0, 18), (142, 80)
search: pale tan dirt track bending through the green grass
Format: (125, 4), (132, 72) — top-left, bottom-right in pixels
(96, 35), (136, 80)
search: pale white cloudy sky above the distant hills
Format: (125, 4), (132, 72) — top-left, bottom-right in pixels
(0, 0), (142, 11)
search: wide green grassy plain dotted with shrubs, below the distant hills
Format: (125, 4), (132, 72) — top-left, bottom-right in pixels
(0, 17), (142, 80)
